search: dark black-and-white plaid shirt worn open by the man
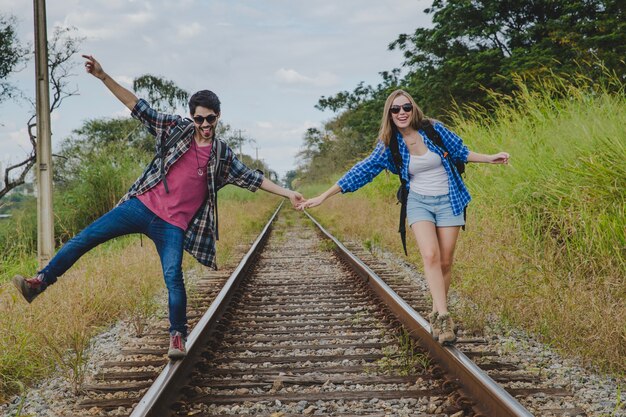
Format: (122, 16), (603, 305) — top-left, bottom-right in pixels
(118, 99), (263, 269)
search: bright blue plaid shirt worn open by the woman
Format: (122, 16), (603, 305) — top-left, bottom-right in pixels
(337, 123), (472, 215)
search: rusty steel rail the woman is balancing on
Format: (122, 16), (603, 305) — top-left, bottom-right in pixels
(305, 211), (533, 417)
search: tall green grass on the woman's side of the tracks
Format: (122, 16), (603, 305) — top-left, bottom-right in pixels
(305, 72), (626, 375)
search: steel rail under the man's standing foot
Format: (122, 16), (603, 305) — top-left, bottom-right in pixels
(130, 200), (284, 417)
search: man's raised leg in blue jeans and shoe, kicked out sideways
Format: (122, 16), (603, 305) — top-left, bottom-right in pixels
(13, 198), (151, 303)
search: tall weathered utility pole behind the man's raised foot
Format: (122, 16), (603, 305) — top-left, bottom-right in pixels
(33, 0), (54, 267)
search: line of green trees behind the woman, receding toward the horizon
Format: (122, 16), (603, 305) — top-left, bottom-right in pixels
(288, 0), (626, 182)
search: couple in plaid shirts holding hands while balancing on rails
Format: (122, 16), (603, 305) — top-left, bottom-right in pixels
(13, 55), (509, 359)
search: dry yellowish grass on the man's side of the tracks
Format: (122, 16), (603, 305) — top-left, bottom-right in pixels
(0, 188), (278, 402)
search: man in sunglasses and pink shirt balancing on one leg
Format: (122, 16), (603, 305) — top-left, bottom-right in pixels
(13, 55), (304, 359)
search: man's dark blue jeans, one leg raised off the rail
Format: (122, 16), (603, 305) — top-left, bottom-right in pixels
(40, 198), (187, 337)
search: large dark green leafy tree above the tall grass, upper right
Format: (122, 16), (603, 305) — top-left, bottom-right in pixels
(389, 0), (626, 113)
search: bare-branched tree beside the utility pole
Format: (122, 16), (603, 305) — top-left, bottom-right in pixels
(0, 27), (82, 199)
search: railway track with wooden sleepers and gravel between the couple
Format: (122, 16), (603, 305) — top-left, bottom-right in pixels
(66, 203), (585, 417)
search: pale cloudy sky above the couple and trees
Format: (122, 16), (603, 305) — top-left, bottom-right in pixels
(0, 0), (431, 177)
